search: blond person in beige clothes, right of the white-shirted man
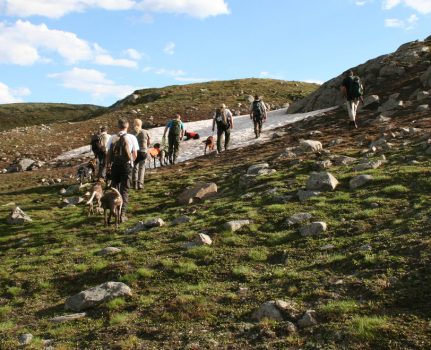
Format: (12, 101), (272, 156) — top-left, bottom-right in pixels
(132, 119), (151, 190)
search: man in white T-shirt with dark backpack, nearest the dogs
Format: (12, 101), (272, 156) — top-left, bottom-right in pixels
(107, 119), (139, 222)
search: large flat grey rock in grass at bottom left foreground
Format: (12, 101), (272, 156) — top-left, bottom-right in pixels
(65, 282), (132, 312)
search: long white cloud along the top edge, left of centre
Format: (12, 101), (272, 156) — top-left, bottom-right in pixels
(0, 0), (229, 19)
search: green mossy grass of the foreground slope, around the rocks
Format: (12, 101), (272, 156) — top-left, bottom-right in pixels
(0, 109), (431, 350)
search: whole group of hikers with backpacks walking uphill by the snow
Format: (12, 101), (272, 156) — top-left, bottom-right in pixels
(91, 71), (363, 222)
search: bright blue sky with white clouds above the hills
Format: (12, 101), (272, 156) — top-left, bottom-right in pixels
(0, 0), (431, 106)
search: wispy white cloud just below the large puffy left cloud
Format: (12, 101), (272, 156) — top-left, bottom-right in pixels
(48, 67), (137, 99)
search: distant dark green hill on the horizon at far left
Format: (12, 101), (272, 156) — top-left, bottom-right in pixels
(0, 103), (104, 131)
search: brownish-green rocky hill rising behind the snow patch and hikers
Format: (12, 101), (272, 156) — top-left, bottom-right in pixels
(0, 79), (318, 164)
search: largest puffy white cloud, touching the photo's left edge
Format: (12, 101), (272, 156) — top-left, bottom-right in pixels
(0, 20), (137, 68)
